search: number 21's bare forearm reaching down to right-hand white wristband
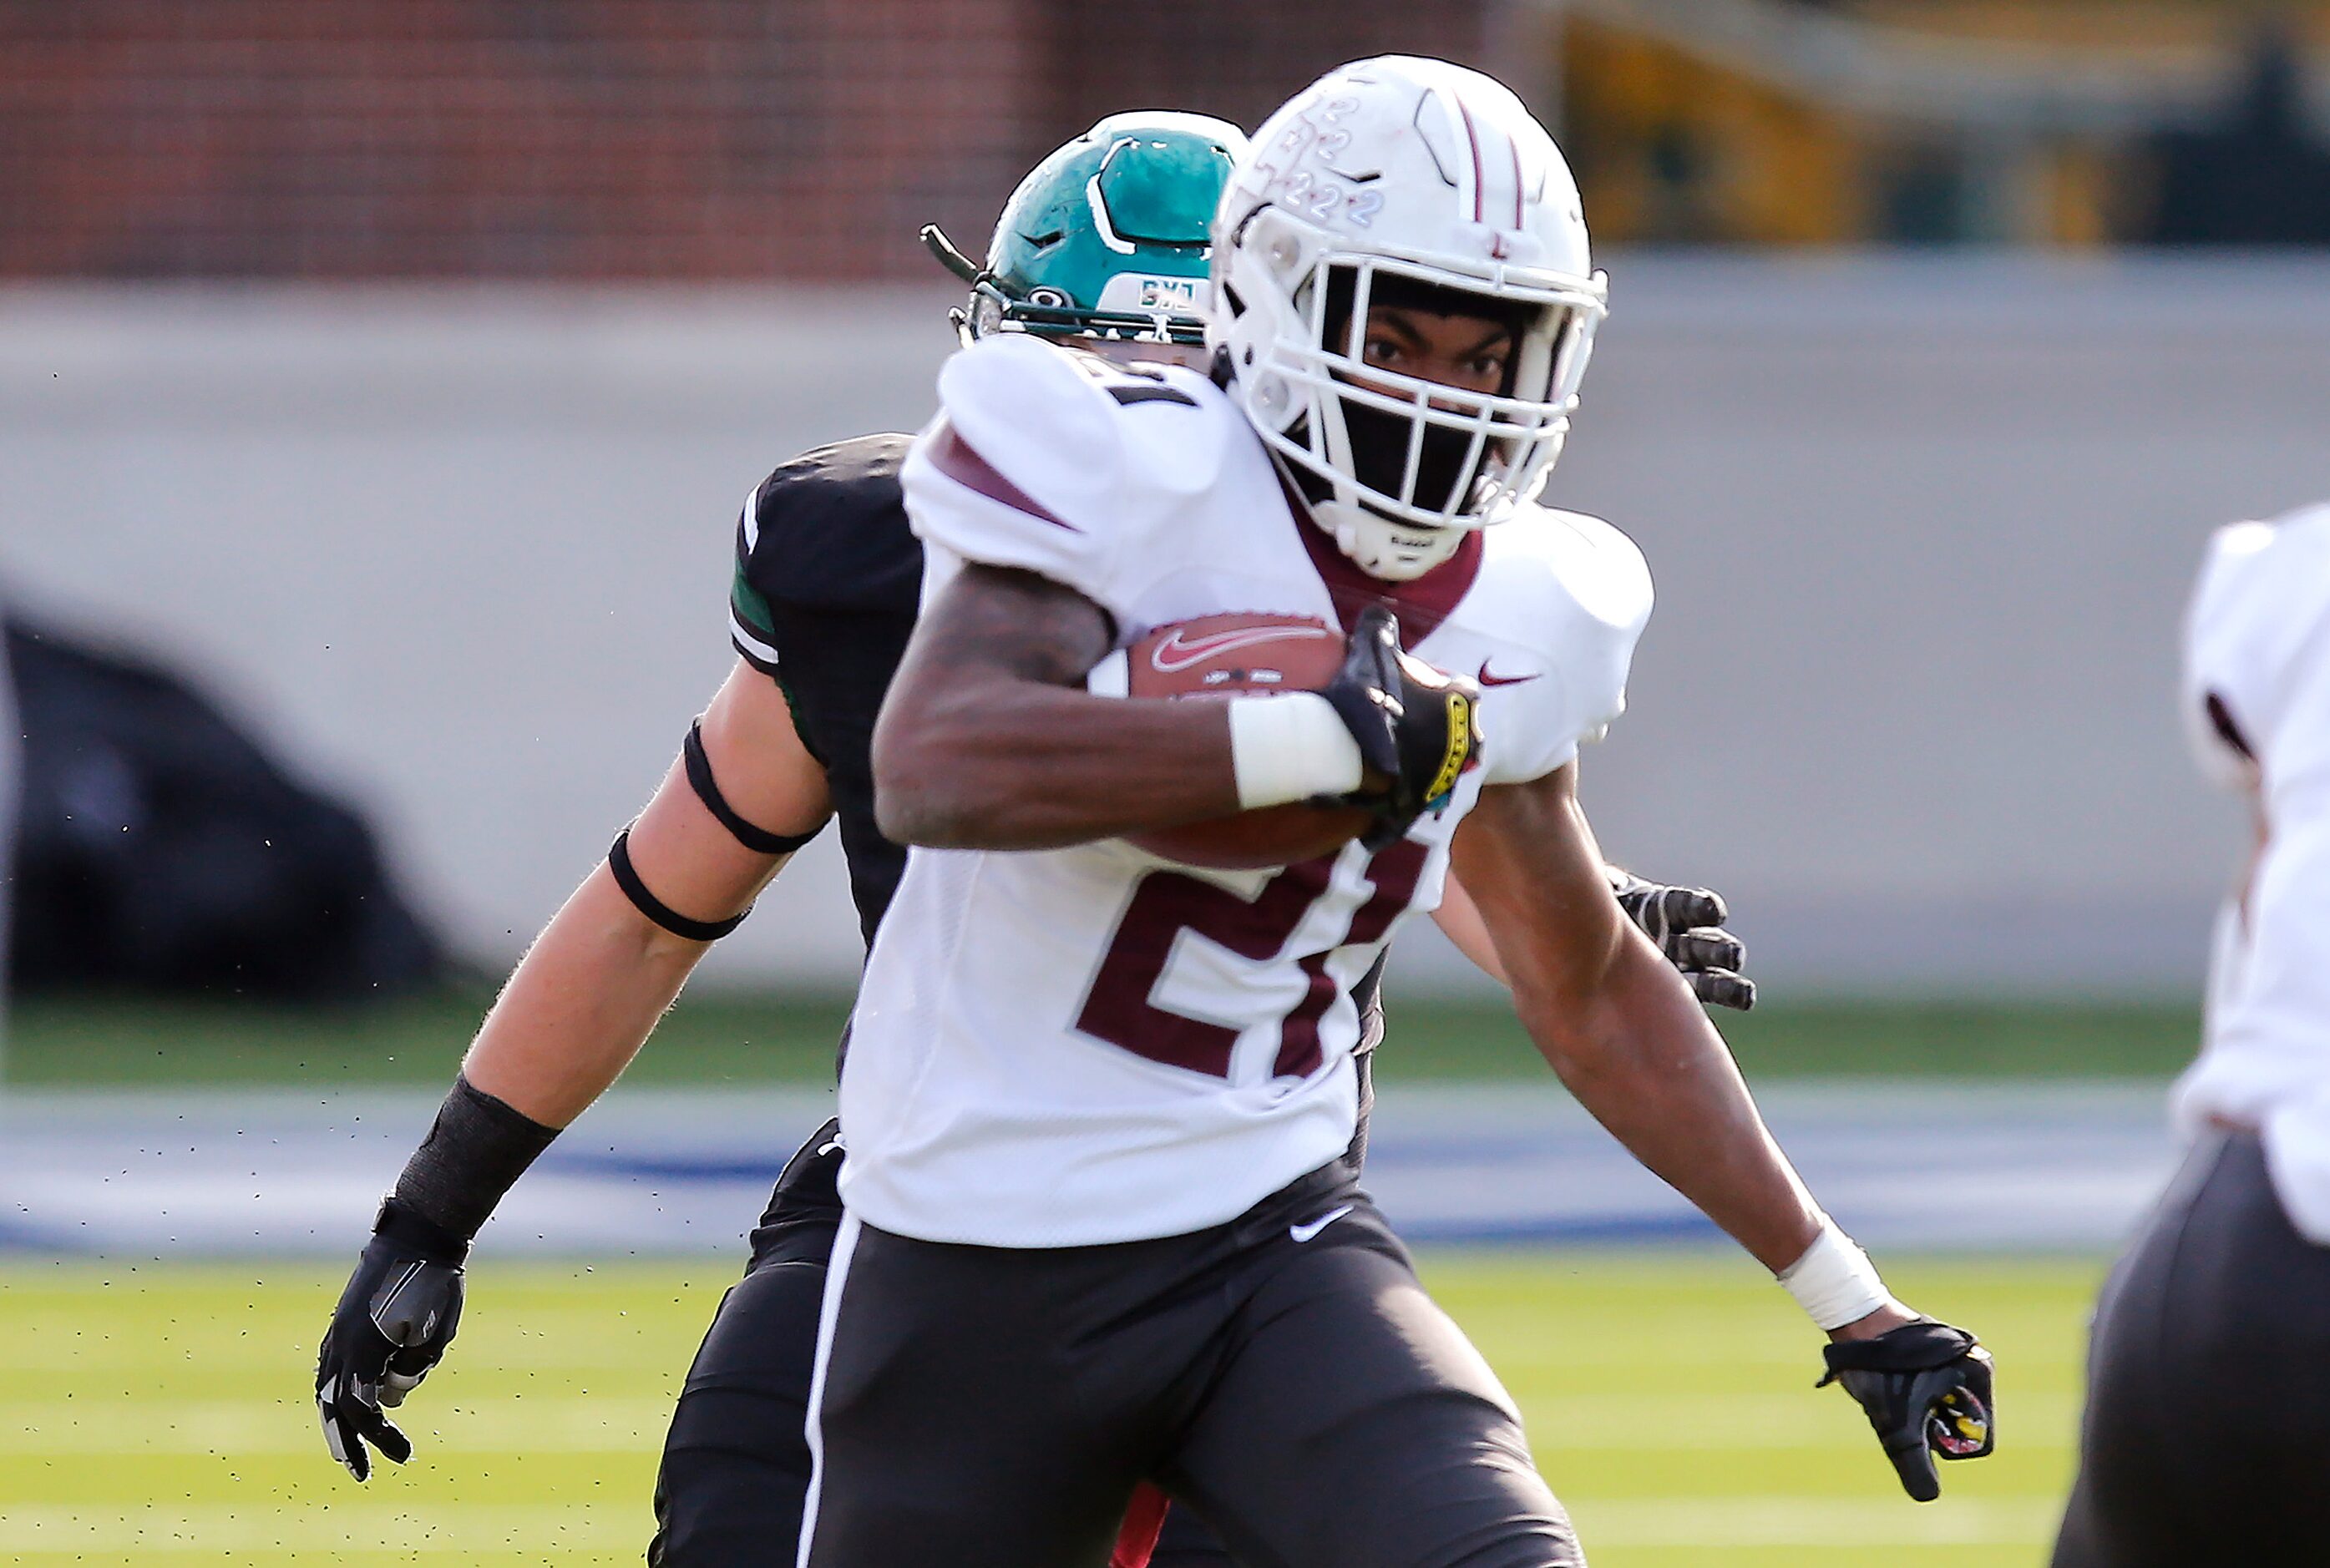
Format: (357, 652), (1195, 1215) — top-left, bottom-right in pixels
(1515, 934), (1820, 1272)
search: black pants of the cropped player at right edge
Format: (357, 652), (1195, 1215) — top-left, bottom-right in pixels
(2055, 1132), (2330, 1568)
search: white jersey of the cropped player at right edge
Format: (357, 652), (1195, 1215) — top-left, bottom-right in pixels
(2176, 506), (2330, 1244)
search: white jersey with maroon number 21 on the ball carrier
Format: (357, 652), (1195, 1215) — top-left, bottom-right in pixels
(841, 336), (1649, 1247)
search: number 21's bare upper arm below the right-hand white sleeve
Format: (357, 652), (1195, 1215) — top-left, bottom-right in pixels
(1449, 764), (1631, 999)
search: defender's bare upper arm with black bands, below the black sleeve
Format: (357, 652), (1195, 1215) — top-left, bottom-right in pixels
(629, 660), (832, 920)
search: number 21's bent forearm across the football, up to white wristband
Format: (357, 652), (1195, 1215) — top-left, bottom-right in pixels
(874, 678), (1237, 851)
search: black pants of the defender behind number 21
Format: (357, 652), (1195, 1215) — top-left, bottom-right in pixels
(648, 1120), (1230, 1568)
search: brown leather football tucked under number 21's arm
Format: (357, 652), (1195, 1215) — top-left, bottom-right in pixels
(1126, 615), (1368, 872)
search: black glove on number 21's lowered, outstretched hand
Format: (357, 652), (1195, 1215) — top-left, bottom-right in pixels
(1813, 1318), (1997, 1503)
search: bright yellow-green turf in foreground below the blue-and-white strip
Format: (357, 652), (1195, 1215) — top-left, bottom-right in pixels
(0, 1253), (2100, 1568)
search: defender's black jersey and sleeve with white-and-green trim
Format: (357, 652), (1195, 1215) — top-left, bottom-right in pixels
(729, 436), (923, 943)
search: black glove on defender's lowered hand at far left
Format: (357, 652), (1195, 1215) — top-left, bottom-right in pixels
(315, 1197), (469, 1482)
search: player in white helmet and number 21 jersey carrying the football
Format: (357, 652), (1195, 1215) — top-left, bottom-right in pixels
(802, 58), (1990, 1568)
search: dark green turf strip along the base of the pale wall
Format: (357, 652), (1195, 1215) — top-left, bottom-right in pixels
(5, 993), (2200, 1088)
